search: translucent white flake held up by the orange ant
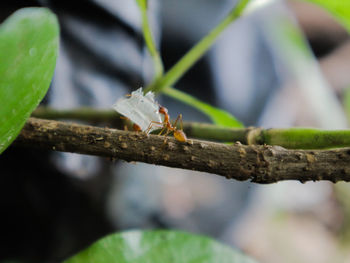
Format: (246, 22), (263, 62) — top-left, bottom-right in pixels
(112, 88), (162, 132)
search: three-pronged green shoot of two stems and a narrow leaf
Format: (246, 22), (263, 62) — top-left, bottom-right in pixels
(141, 0), (249, 128)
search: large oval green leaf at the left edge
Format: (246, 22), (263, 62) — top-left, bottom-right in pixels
(0, 8), (59, 154)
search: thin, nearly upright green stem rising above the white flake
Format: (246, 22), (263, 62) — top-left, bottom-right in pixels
(137, 1), (164, 80)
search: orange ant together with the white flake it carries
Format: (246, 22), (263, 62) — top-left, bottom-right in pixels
(112, 88), (187, 142)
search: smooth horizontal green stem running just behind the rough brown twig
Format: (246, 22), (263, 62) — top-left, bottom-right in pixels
(32, 106), (350, 149)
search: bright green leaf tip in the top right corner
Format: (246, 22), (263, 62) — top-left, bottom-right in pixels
(304, 0), (350, 32)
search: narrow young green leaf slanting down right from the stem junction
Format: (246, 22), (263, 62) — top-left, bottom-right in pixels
(163, 88), (244, 128)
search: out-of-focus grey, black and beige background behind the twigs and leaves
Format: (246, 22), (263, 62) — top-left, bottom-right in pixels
(0, 0), (350, 263)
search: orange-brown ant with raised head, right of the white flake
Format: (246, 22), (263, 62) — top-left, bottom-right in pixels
(146, 105), (187, 142)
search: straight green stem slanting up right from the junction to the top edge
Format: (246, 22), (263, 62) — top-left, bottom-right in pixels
(145, 0), (249, 92)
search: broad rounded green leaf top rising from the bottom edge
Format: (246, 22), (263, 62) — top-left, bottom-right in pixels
(64, 230), (255, 263)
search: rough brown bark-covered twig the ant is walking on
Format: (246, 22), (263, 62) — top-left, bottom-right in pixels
(15, 118), (350, 183)
